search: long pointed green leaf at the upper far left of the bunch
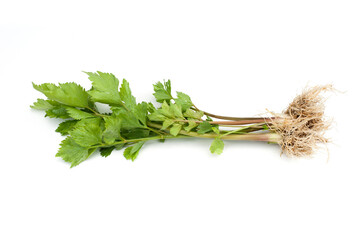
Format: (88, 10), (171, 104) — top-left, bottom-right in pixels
(33, 82), (88, 108)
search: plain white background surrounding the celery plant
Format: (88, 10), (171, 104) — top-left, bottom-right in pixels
(0, 0), (361, 240)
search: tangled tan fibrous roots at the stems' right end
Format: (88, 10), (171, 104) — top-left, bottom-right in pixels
(270, 85), (333, 156)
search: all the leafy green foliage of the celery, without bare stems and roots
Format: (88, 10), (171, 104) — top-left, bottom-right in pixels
(31, 71), (235, 167)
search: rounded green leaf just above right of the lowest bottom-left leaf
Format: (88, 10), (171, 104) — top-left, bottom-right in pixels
(70, 121), (102, 147)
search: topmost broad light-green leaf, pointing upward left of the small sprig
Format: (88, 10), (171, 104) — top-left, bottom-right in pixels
(85, 71), (123, 106)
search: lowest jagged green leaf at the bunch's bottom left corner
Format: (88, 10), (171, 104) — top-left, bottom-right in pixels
(56, 137), (93, 167)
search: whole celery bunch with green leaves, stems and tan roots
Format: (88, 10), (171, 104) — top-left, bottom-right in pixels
(31, 71), (332, 166)
